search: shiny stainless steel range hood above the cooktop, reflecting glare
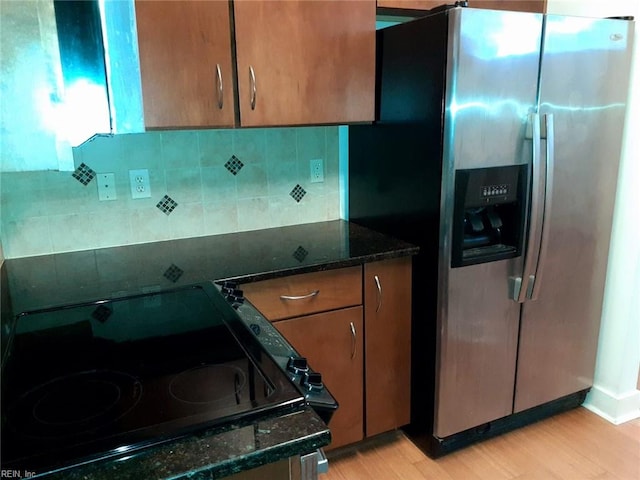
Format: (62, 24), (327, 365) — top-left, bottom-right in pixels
(0, 0), (144, 172)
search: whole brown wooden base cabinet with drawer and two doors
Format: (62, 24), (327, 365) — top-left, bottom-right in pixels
(242, 257), (411, 448)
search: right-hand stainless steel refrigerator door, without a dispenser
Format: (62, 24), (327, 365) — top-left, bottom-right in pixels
(514, 16), (633, 412)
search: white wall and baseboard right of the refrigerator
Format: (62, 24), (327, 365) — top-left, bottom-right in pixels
(547, 0), (640, 423)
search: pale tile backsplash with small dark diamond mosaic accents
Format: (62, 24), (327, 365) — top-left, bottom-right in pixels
(0, 127), (340, 258)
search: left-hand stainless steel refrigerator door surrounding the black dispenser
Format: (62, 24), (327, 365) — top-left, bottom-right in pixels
(434, 8), (542, 438)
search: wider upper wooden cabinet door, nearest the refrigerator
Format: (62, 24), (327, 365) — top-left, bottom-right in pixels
(234, 0), (376, 126)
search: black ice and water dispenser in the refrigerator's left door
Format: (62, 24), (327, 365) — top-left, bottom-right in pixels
(451, 165), (527, 267)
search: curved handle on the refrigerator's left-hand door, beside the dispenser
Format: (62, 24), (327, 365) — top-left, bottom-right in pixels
(510, 113), (543, 303)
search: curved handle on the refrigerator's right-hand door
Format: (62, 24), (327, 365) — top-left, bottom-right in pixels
(527, 113), (555, 300)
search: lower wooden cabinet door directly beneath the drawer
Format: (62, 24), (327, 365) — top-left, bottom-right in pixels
(274, 306), (363, 448)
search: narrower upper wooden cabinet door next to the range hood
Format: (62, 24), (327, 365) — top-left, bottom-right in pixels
(136, 1), (235, 129)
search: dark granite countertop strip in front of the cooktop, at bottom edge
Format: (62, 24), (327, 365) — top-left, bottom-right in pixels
(46, 408), (331, 480)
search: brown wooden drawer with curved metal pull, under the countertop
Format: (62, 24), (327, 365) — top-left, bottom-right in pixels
(242, 266), (362, 321)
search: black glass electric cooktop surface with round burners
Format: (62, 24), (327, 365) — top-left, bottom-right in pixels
(1, 284), (304, 474)
